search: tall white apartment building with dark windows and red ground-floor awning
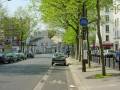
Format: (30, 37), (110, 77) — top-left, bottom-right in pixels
(96, 0), (120, 50)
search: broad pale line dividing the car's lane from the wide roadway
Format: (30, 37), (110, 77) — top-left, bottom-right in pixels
(33, 67), (53, 90)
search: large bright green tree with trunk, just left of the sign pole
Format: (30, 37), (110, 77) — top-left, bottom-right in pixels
(40, 0), (81, 59)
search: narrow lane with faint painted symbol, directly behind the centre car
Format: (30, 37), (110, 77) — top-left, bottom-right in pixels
(41, 65), (78, 90)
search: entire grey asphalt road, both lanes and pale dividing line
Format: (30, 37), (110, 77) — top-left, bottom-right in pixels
(0, 55), (77, 90)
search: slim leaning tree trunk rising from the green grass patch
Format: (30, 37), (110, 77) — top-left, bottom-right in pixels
(96, 0), (106, 76)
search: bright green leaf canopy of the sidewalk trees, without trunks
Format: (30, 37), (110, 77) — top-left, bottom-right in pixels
(40, 0), (112, 43)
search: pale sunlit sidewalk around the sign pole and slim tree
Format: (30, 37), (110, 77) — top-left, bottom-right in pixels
(68, 58), (120, 90)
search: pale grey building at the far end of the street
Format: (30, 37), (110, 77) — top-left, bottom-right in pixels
(32, 31), (56, 53)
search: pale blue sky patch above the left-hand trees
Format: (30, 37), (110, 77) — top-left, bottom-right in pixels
(0, 0), (29, 15)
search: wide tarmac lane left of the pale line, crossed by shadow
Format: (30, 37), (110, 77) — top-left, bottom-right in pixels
(0, 55), (51, 90)
